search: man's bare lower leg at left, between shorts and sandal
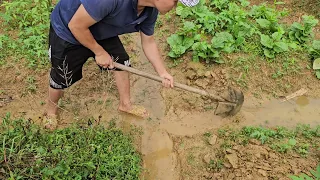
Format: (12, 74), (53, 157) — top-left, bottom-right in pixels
(46, 87), (63, 116)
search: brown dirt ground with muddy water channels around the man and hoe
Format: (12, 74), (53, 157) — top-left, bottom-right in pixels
(0, 1), (320, 180)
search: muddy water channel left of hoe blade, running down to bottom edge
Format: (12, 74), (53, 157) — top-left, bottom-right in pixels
(123, 37), (228, 180)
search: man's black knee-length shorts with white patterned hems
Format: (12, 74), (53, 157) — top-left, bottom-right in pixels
(48, 26), (130, 89)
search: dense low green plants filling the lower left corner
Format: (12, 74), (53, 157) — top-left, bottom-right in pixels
(0, 114), (142, 180)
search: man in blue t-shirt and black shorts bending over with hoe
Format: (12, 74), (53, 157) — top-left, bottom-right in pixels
(44, 0), (199, 129)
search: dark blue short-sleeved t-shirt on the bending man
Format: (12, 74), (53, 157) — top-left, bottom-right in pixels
(51, 0), (158, 44)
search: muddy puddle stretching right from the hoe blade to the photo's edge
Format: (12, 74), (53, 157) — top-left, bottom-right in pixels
(242, 96), (320, 127)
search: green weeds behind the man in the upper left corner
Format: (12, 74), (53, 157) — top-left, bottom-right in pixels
(0, 0), (53, 68)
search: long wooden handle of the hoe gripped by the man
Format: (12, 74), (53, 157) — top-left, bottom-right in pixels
(114, 62), (226, 102)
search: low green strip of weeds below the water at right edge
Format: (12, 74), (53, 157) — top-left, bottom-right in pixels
(218, 125), (320, 156)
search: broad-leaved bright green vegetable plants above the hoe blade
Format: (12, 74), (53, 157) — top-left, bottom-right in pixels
(167, 0), (318, 78)
